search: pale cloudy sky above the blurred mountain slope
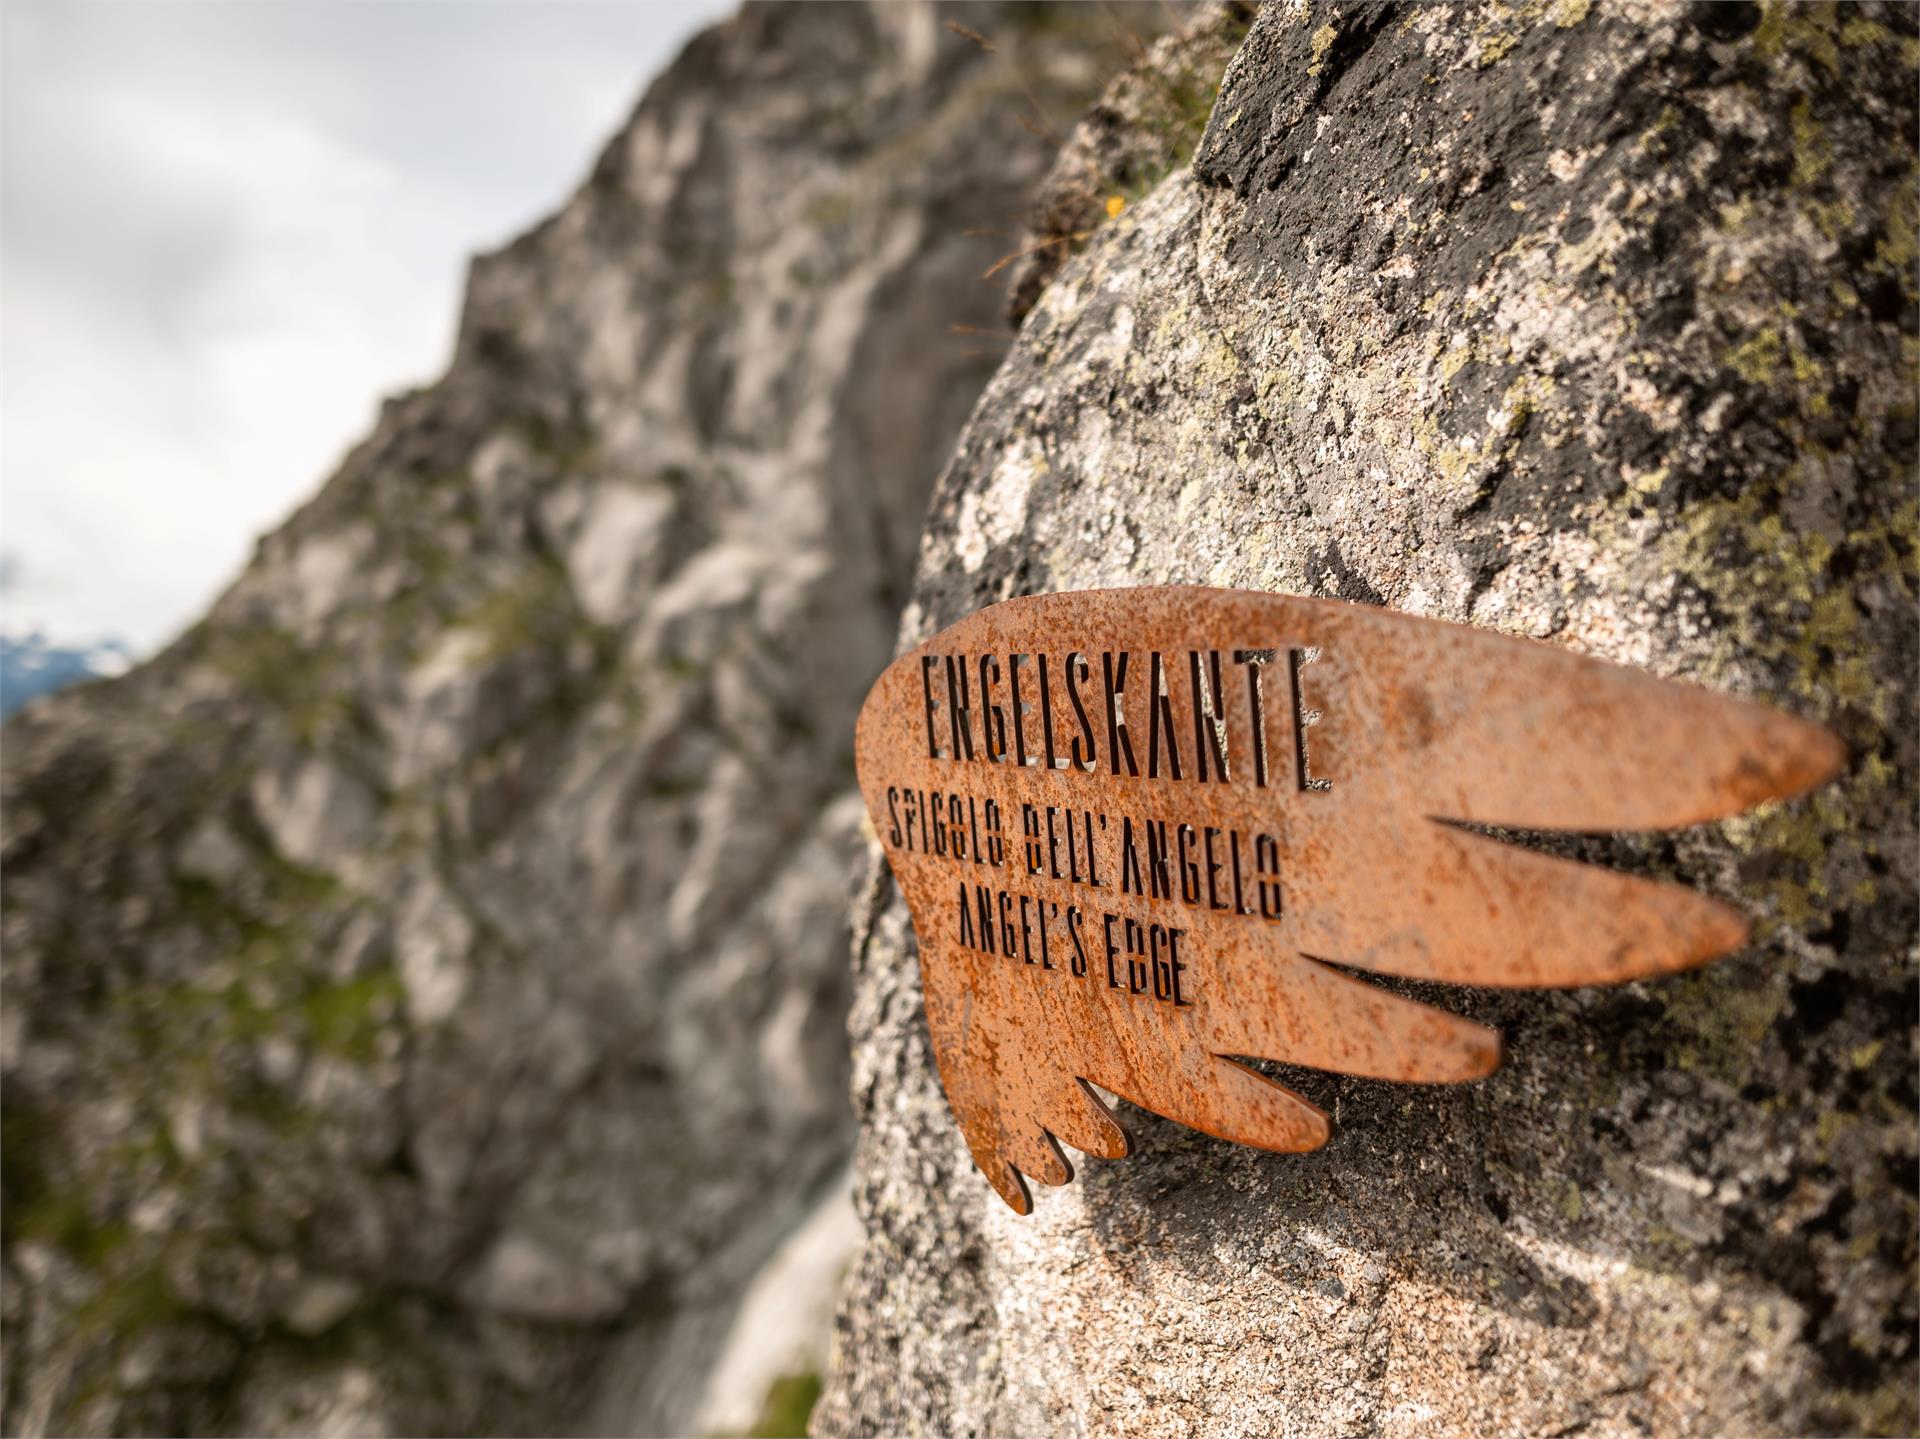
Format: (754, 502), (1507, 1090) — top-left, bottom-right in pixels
(0, 0), (732, 651)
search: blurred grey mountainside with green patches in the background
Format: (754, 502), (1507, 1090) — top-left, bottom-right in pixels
(4, 4), (1144, 1433)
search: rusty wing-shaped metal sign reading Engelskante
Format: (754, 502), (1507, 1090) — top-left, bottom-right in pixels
(856, 586), (1845, 1214)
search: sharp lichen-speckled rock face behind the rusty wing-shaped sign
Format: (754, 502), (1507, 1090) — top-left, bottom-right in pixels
(814, 0), (1920, 1435)
